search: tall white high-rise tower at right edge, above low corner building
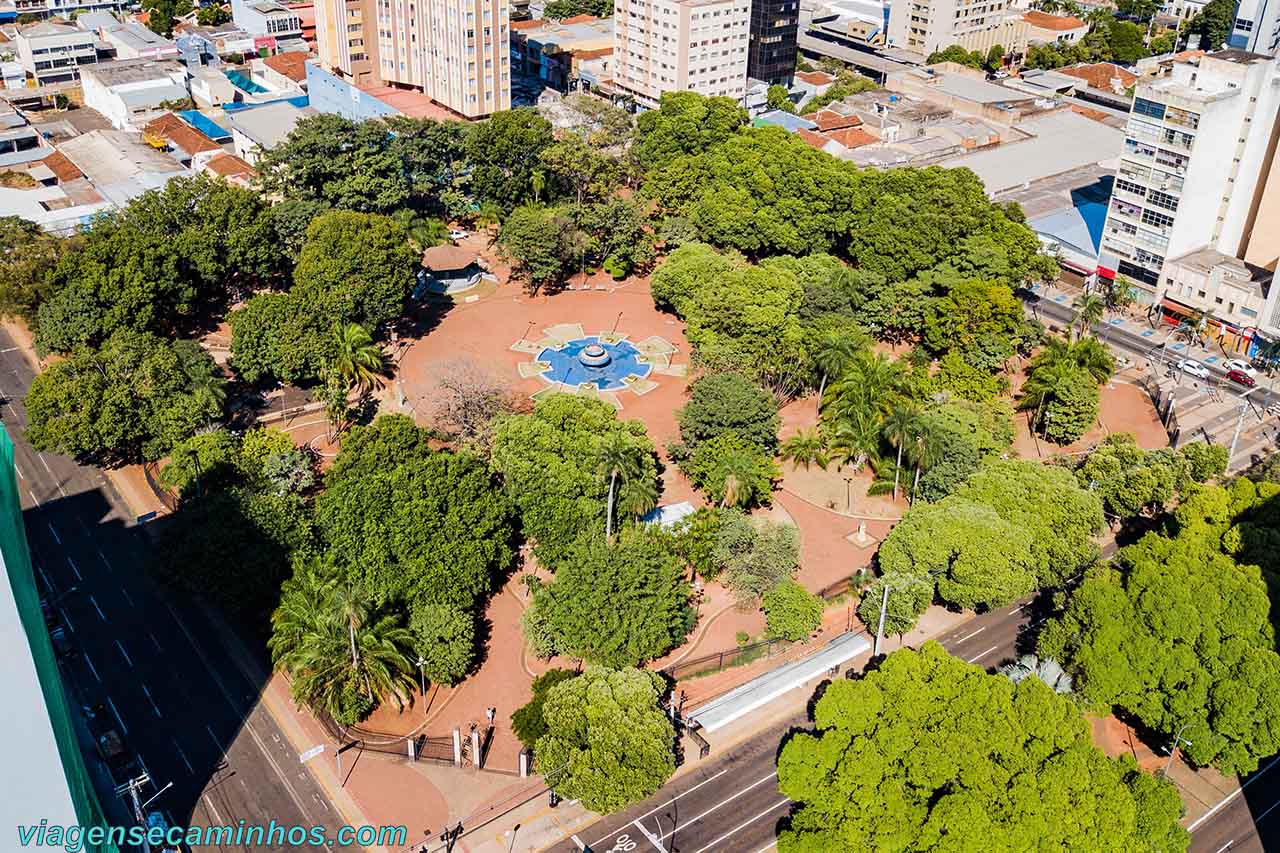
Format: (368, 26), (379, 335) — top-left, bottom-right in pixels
(1098, 49), (1280, 305)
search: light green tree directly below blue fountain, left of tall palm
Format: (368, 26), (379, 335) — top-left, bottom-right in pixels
(490, 394), (658, 565)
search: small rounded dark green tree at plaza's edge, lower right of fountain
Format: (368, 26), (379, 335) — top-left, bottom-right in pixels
(676, 373), (781, 452)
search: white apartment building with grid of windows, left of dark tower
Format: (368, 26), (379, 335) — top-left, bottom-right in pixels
(613, 0), (751, 106)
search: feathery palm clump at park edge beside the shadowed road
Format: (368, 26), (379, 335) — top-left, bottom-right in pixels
(268, 566), (413, 725)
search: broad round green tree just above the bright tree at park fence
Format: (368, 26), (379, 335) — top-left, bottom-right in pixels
(534, 528), (696, 666)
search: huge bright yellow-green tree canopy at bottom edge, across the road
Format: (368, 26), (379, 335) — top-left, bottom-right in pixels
(778, 642), (1190, 853)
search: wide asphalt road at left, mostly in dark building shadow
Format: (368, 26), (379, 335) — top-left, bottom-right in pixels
(0, 330), (358, 850)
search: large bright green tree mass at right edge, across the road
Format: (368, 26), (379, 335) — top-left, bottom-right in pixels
(1039, 478), (1280, 774)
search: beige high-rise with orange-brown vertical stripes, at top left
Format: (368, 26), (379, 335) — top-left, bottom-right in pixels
(316, 0), (511, 118)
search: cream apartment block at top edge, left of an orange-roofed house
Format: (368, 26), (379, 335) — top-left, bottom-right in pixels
(888, 0), (1029, 56)
